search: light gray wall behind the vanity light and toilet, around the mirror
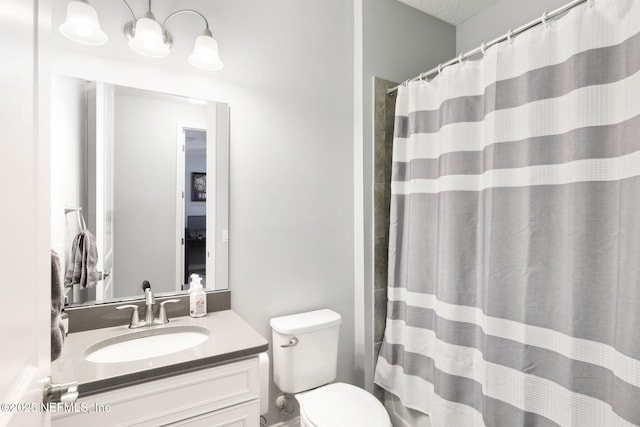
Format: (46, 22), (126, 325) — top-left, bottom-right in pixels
(52, 0), (354, 423)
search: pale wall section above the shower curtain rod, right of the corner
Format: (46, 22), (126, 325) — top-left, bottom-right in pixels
(456, 0), (569, 52)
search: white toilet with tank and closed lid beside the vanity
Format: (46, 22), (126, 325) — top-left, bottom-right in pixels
(270, 309), (391, 427)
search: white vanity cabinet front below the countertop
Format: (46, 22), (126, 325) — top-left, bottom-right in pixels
(51, 357), (260, 427)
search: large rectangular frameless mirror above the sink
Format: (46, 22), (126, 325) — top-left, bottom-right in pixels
(51, 75), (229, 304)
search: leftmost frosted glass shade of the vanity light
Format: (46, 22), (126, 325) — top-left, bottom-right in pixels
(58, 1), (109, 46)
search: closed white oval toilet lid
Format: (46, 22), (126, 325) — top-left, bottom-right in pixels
(300, 383), (391, 427)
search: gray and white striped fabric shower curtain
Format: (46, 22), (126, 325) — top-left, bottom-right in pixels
(375, 0), (640, 427)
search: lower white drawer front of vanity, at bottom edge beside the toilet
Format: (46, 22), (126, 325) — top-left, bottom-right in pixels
(169, 400), (260, 427)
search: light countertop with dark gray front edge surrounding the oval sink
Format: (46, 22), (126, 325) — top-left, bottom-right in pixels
(51, 310), (269, 397)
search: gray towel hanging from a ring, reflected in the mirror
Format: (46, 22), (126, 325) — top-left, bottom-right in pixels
(64, 230), (98, 288)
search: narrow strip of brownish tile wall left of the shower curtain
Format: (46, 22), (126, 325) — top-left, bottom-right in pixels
(373, 77), (397, 401)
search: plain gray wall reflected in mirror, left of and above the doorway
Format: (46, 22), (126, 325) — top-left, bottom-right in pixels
(113, 87), (206, 298)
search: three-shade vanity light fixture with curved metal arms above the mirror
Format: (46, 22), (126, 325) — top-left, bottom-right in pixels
(59, 0), (224, 71)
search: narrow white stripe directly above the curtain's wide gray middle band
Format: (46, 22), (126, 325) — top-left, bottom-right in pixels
(391, 151), (640, 195)
